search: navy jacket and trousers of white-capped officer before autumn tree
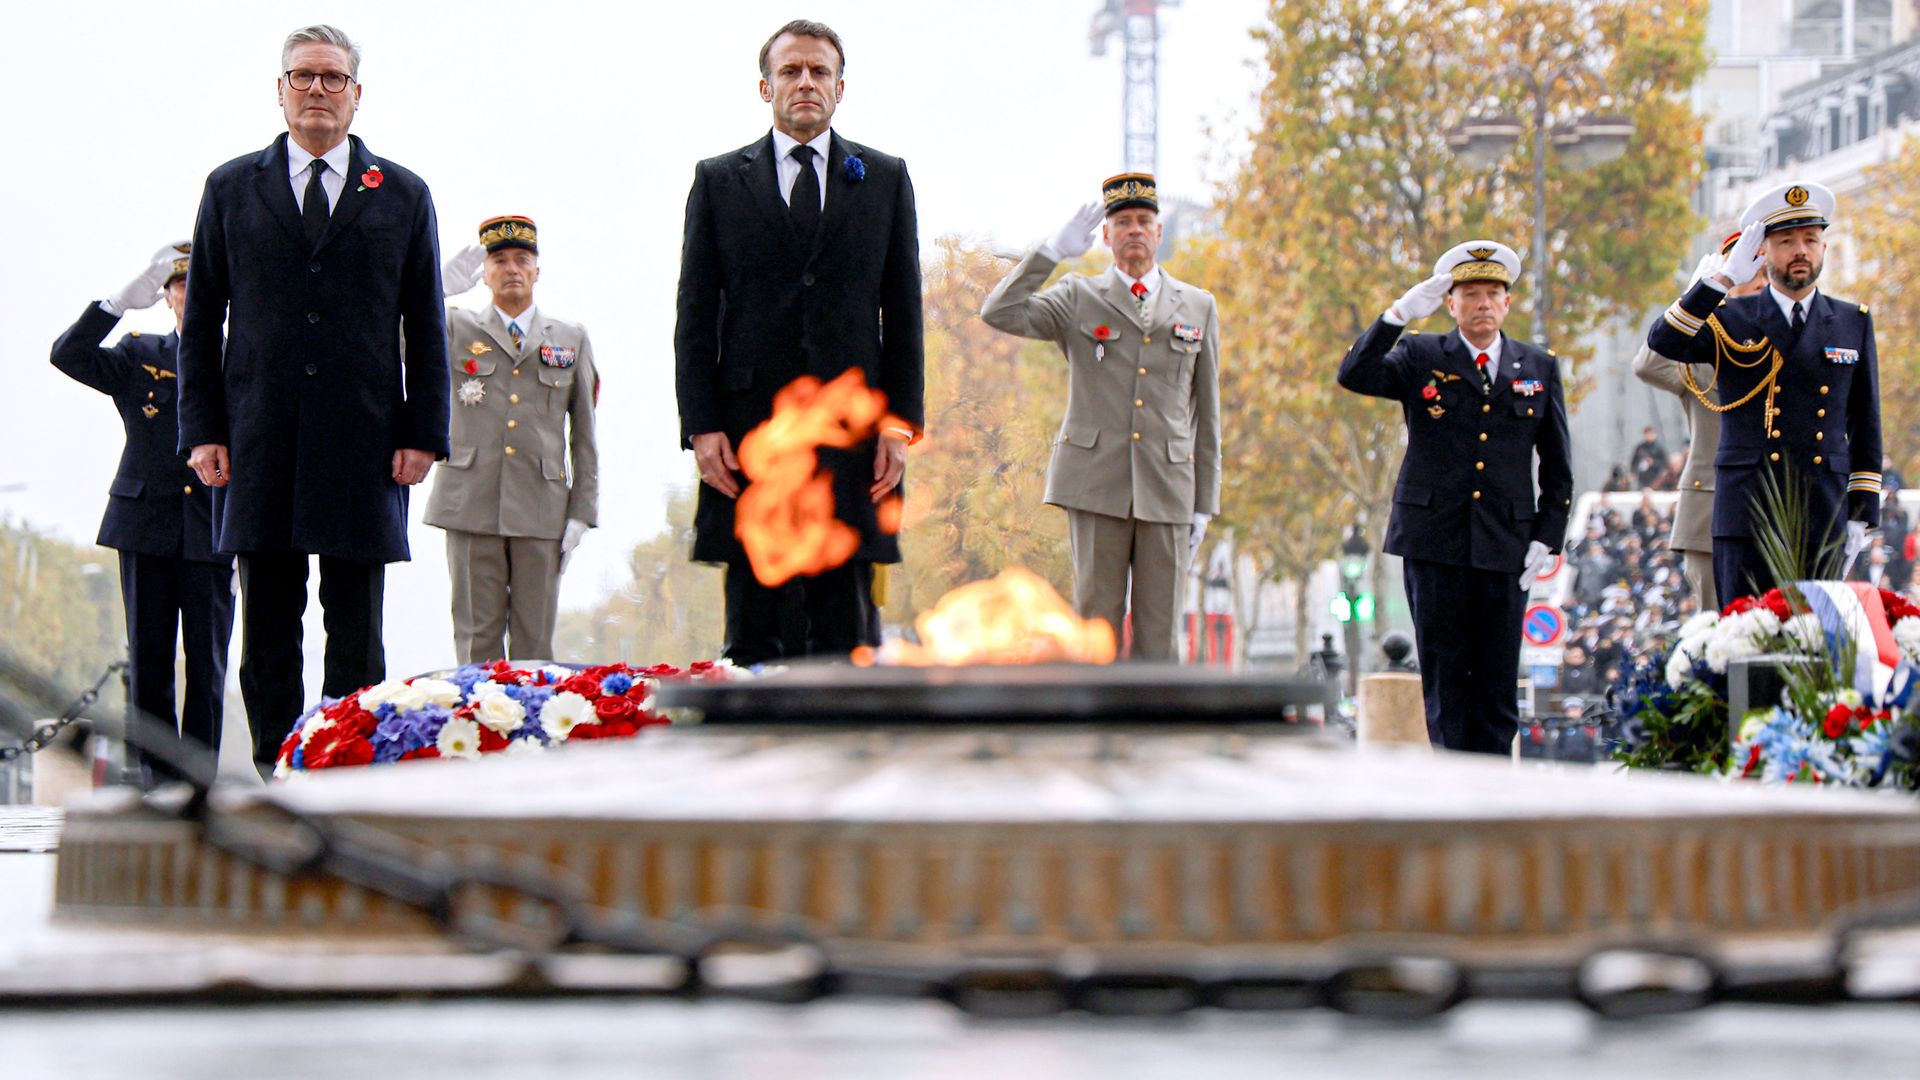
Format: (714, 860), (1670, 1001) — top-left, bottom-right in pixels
(1338, 319), (1572, 753)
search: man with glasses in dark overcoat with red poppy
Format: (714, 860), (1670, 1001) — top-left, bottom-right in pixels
(180, 25), (447, 771)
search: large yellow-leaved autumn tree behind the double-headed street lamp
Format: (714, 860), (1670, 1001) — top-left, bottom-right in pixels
(1196, 0), (1707, 634)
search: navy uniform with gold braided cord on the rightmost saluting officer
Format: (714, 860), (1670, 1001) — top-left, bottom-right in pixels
(1647, 282), (1880, 601)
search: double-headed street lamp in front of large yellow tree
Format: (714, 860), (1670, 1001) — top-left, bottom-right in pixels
(1446, 63), (1634, 348)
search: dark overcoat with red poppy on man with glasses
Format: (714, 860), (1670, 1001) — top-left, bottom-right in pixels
(180, 135), (447, 563)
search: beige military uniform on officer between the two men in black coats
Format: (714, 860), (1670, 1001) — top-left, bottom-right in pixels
(426, 306), (599, 663)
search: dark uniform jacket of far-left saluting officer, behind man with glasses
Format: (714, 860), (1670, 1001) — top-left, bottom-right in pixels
(54, 304), (232, 563)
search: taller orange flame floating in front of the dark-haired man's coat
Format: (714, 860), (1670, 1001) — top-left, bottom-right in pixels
(733, 367), (906, 588)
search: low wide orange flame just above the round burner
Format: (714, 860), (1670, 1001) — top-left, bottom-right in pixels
(854, 567), (1117, 667)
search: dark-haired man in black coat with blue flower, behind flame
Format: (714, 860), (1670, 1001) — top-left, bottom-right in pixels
(674, 19), (924, 665)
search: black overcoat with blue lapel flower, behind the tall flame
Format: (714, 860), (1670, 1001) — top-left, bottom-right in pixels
(674, 133), (925, 563)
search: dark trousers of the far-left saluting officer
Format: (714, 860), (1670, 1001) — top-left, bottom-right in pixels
(119, 552), (234, 780)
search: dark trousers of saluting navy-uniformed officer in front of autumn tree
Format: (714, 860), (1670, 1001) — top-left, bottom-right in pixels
(1404, 559), (1526, 753)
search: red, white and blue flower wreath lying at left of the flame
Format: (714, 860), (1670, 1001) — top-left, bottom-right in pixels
(273, 661), (745, 776)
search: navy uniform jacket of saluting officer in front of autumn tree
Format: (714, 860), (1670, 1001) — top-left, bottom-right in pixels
(1340, 319), (1572, 575)
